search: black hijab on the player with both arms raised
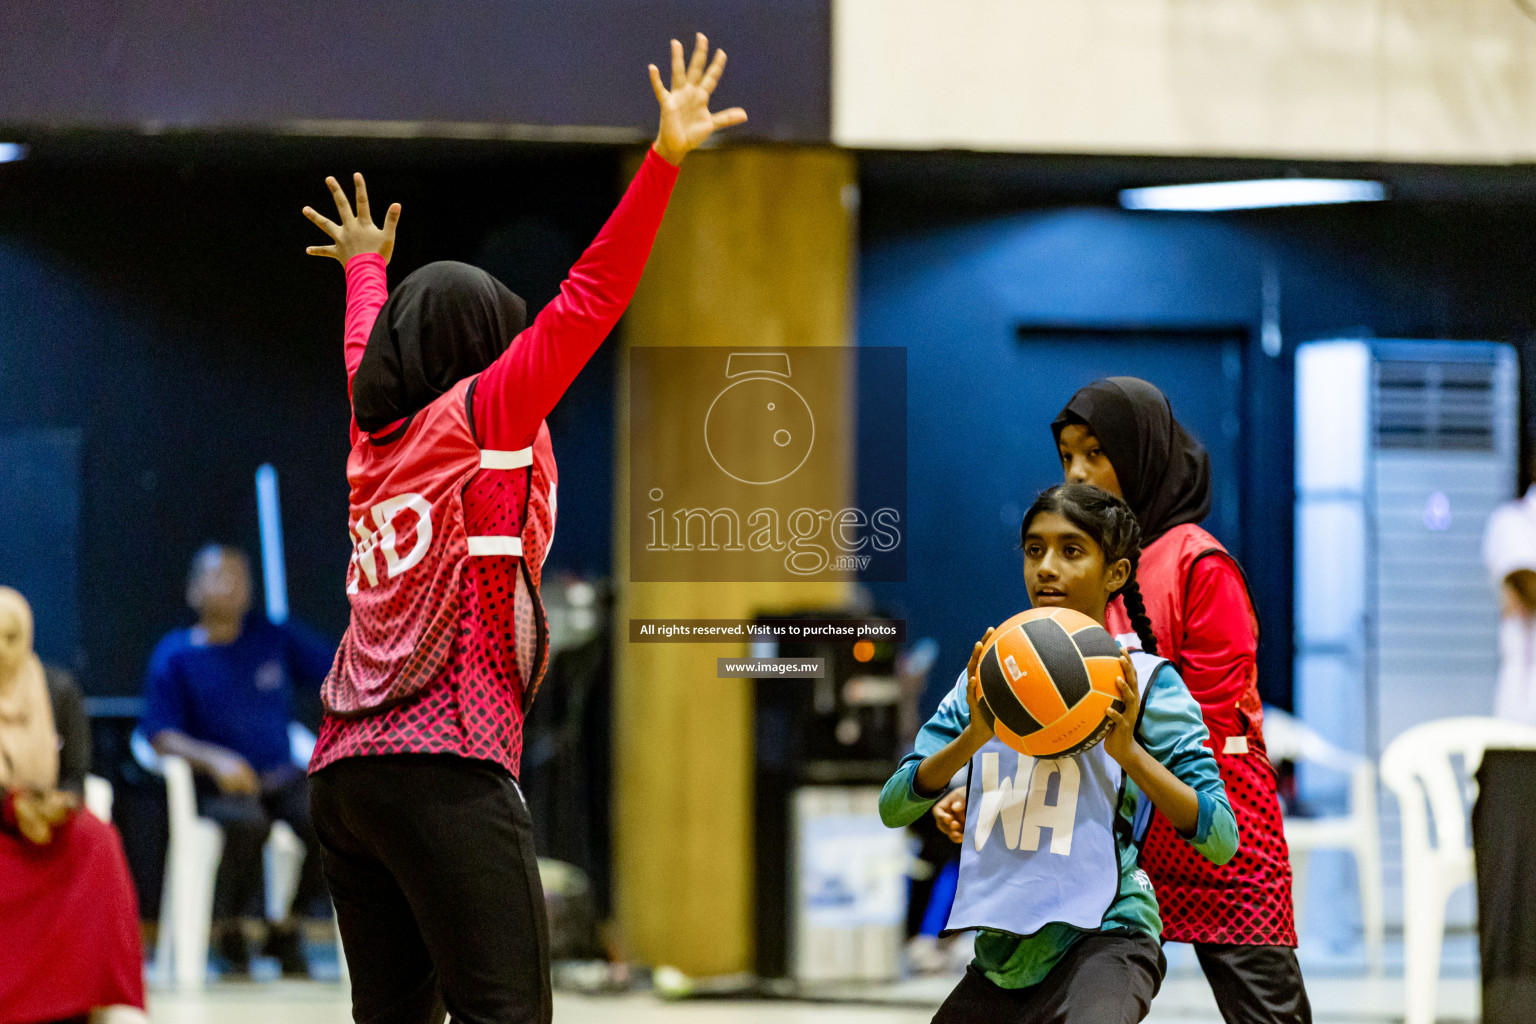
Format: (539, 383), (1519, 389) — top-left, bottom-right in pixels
(352, 261), (527, 433)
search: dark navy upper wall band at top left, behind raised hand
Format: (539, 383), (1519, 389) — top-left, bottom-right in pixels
(0, 0), (831, 143)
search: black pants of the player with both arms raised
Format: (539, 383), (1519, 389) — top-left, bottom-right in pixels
(310, 754), (551, 1024)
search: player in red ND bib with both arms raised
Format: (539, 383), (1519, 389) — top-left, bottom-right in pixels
(304, 35), (746, 1024)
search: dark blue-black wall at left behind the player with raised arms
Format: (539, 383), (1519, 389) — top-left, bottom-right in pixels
(0, 138), (621, 694)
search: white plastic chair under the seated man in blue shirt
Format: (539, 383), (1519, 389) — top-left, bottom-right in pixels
(129, 722), (315, 990)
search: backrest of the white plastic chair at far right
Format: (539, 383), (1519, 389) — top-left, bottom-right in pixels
(1381, 717), (1536, 854)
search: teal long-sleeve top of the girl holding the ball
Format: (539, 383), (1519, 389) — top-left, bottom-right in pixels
(880, 665), (1238, 989)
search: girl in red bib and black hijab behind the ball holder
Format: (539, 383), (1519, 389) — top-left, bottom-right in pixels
(1051, 378), (1312, 1024)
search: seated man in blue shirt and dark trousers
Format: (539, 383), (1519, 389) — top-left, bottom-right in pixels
(140, 543), (335, 973)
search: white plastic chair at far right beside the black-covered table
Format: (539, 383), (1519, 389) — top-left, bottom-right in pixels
(1381, 718), (1536, 1024)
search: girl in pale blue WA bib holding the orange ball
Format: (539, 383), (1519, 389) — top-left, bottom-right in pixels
(880, 484), (1238, 1024)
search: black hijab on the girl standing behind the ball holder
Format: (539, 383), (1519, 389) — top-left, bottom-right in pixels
(1051, 376), (1210, 545)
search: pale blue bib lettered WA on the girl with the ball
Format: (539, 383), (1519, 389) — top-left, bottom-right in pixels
(946, 651), (1166, 935)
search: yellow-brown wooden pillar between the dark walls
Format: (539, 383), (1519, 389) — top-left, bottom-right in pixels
(614, 147), (857, 975)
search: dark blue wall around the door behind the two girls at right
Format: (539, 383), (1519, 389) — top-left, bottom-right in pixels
(859, 196), (1536, 709)
